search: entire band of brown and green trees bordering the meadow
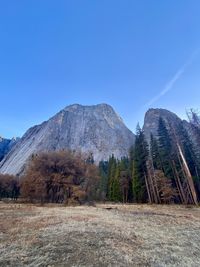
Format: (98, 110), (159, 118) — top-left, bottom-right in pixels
(0, 111), (200, 205)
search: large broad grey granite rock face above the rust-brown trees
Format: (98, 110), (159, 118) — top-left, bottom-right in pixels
(0, 104), (135, 175)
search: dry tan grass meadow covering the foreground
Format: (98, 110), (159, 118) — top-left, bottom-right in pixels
(0, 203), (200, 267)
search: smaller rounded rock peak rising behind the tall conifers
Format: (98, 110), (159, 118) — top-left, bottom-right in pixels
(143, 109), (182, 142)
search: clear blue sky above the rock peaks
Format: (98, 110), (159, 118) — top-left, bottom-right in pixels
(0, 0), (200, 137)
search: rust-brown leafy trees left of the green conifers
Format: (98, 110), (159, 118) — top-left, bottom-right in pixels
(0, 151), (100, 204)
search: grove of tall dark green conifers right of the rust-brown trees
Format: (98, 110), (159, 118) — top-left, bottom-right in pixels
(99, 110), (200, 204)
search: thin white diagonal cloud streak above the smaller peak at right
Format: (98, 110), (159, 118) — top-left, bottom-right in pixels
(145, 50), (199, 107)
